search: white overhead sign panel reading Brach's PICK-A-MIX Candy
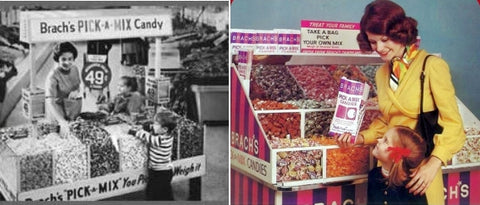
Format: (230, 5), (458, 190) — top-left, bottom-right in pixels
(20, 9), (173, 43)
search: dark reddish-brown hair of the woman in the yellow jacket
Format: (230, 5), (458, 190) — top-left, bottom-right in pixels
(357, 0), (418, 52)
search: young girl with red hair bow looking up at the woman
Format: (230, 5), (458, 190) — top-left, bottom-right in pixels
(367, 126), (427, 204)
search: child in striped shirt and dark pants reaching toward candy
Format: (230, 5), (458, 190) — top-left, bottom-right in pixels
(128, 108), (179, 201)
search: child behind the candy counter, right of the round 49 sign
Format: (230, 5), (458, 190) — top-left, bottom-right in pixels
(99, 76), (145, 115)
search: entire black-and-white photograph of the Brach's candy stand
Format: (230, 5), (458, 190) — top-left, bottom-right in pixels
(0, 1), (229, 204)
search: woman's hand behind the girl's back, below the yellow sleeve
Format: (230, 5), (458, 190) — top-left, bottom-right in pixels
(405, 156), (442, 195)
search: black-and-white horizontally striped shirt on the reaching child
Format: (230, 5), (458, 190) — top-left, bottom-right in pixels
(135, 130), (173, 171)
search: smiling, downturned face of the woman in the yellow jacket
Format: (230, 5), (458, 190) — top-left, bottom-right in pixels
(366, 32), (405, 63)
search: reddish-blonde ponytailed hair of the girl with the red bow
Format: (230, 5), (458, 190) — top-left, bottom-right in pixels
(388, 126), (427, 186)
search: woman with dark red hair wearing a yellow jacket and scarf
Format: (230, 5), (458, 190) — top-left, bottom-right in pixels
(337, 0), (465, 204)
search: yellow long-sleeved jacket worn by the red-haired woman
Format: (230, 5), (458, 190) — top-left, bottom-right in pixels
(361, 50), (465, 165)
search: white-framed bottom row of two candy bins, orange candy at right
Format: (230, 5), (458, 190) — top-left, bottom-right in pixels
(272, 144), (373, 187)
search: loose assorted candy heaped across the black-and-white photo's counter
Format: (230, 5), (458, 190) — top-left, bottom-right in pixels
(0, 113), (204, 192)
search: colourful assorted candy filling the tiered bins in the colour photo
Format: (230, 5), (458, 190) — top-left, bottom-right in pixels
(250, 65), (380, 182)
